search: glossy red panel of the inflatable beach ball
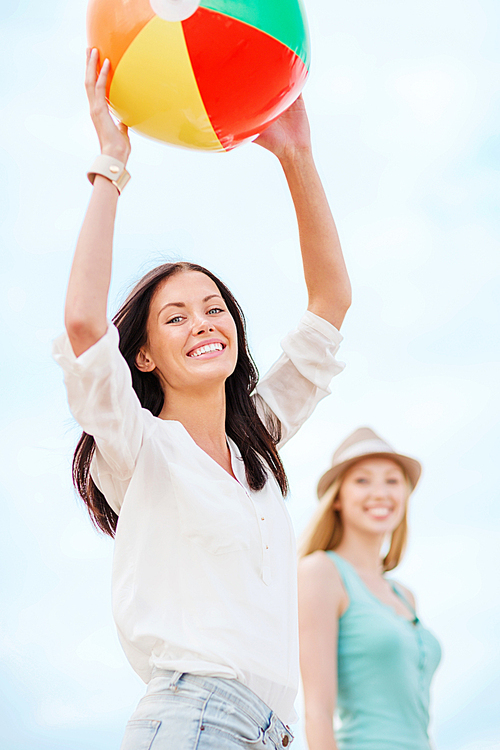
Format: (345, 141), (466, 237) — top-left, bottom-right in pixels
(182, 8), (307, 150)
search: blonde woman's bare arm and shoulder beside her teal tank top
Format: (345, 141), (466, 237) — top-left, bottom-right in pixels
(299, 551), (347, 750)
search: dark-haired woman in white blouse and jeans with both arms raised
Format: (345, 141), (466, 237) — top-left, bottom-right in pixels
(55, 50), (350, 750)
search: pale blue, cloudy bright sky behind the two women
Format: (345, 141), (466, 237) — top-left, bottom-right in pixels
(0, 0), (500, 750)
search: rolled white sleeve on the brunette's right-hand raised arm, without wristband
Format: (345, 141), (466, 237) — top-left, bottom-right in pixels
(256, 310), (345, 447)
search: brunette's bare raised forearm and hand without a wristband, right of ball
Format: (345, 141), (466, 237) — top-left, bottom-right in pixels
(256, 96), (351, 328)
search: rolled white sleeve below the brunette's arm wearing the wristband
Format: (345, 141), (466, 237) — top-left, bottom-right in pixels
(52, 325), (143, 480)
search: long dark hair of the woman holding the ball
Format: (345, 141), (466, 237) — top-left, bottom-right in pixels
(73, 262), (288, 537)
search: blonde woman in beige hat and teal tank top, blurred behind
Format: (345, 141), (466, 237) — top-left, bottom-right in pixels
(299, 427), (441, 750)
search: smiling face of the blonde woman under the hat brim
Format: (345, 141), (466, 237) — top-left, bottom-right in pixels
(334, 457), (408, 535)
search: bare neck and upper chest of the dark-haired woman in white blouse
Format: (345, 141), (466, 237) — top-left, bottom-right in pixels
(159, 385), (230, 468)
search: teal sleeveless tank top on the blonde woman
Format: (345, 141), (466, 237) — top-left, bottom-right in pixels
(327, 550), (441, 750)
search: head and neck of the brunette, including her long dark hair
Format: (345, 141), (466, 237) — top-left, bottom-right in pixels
(67, 263), (287, 536)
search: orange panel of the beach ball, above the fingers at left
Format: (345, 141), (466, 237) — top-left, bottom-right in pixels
(87, 0), (155, 96)
